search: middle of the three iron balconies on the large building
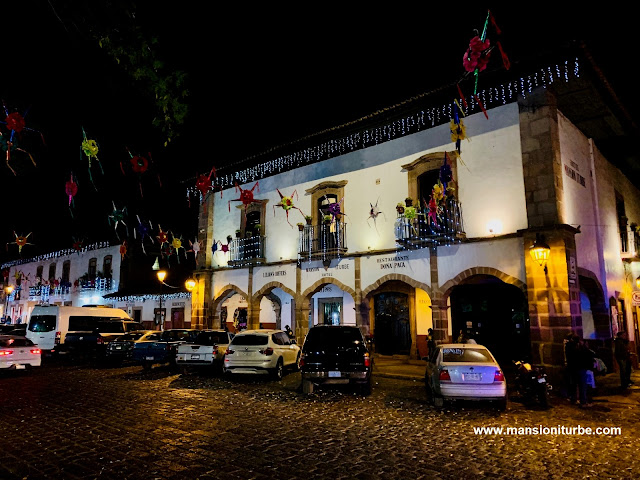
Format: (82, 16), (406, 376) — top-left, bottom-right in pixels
(298, 221), (347, 260)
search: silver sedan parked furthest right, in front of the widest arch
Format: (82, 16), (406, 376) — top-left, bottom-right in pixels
(425, 343), (508, 410)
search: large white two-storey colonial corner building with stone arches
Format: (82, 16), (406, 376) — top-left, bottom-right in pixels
(192, 50), (640, 374)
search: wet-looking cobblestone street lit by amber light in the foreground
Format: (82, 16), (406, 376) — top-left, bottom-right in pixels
(0, 363), (640, 480)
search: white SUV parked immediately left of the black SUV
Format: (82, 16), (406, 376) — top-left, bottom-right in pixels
(223, 330), (300, 380)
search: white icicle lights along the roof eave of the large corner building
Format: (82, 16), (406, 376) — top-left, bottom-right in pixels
(187, 57), (580, 200)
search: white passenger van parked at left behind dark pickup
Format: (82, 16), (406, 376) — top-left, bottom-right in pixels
(26, 305), (131, 353)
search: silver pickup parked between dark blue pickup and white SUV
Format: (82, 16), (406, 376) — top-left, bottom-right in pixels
(176, 330), (234, 371)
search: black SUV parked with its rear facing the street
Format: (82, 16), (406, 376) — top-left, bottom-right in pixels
(300, 325), (373, 395)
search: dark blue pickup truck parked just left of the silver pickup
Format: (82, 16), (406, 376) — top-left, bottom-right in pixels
(131, 328), (202, 370)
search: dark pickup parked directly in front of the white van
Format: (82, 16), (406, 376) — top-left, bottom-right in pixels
(64, 319), (144, 360)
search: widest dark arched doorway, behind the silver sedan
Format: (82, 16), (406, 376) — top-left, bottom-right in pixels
(451, 275), (531, 368)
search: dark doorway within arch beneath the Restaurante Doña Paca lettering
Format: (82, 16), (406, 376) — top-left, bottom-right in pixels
(374, 292), (411, 355)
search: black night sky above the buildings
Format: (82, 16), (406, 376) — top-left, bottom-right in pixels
(0, 0), (638, 261)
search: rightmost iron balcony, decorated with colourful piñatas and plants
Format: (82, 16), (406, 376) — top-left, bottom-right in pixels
(395, 199), (466, 250)
